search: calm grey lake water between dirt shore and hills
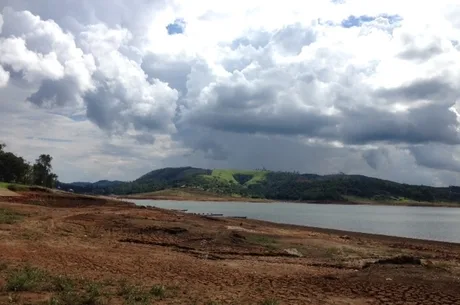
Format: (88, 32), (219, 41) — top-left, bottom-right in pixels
(128, 199), (460, 243)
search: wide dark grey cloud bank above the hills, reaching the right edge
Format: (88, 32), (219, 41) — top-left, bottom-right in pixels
(182, 68), (460, 145)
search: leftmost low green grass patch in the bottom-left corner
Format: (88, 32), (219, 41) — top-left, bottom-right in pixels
(5, 266), (50, 292)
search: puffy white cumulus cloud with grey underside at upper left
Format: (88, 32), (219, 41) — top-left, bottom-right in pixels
(0, 8), (177, 140)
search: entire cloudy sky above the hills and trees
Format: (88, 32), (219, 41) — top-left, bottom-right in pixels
(0, 0), (460, 186)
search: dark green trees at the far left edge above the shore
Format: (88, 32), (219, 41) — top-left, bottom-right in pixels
(0, 143), (58, 188)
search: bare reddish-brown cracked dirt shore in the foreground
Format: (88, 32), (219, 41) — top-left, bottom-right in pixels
(0, 194), (460, 305)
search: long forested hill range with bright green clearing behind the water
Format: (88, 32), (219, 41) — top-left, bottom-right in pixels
(57, 167), (460, 203)
